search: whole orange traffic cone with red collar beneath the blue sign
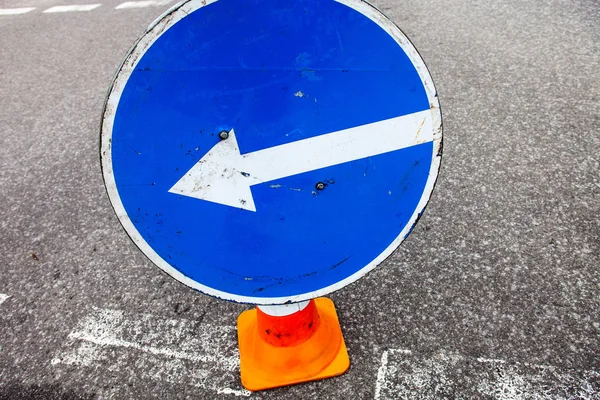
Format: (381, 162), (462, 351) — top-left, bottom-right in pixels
(238, 298), (350, 391)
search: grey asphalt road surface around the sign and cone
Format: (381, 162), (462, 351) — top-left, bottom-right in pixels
(0, 0), (600, 399)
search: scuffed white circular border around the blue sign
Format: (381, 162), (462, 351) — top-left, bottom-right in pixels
(100, 0), (442, 305)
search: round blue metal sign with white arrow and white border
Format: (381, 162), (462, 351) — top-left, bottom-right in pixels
(101, 0), (442, 304)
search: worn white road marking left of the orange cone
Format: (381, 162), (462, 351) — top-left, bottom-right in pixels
(51, 309), (251, 396)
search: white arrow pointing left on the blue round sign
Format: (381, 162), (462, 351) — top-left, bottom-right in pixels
(169, 110), (433, 211)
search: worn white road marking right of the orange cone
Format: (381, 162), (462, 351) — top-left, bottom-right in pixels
(375, 349), (600, 400)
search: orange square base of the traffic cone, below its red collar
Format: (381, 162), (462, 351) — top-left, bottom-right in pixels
(238, 298), (350, 391)
